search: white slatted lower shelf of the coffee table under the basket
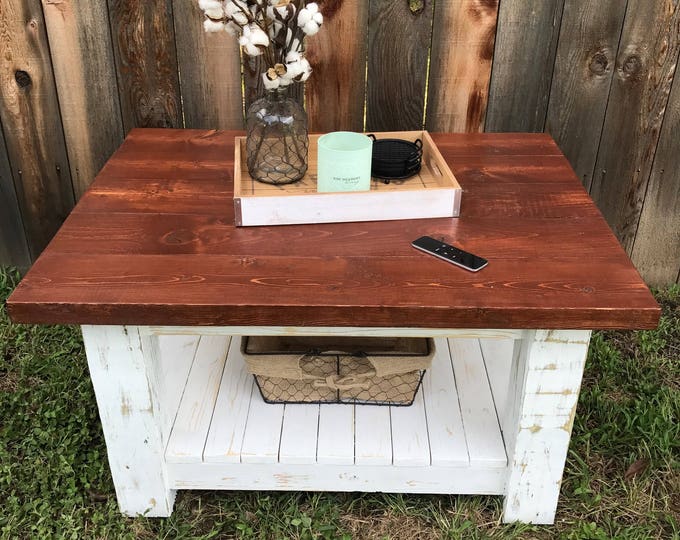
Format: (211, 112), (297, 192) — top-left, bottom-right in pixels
(161, 336), (514, 494)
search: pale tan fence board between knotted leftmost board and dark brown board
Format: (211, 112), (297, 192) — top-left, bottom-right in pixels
(42, 0), (123, 198)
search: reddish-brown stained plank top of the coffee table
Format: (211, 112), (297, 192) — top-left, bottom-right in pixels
(8, 129), (660, 329)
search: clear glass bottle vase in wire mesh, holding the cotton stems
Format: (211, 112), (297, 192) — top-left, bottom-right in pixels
(246, 88), (309, 184)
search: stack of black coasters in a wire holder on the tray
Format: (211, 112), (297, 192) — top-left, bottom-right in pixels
(369, 134), (423, 184)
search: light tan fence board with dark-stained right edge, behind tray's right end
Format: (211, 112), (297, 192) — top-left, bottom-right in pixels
(425, 0), (498, 132)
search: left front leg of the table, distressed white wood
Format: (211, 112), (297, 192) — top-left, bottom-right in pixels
(82, 326), (175, 516)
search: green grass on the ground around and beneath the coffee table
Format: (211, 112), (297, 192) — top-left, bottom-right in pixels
(0, 269), (680, 540)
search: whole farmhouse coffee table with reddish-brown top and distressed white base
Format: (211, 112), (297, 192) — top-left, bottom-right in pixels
(8, 129), (659, 523)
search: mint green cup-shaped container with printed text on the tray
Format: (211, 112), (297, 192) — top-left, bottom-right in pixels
(317, 131), (373, 193)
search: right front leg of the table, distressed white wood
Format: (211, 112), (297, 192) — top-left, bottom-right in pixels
(503, 330), (591, 524)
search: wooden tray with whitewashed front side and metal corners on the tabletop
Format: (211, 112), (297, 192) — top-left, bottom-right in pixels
(234, 131), (462, 226)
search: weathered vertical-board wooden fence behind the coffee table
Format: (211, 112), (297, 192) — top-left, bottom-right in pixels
(0, 0), (680, 285)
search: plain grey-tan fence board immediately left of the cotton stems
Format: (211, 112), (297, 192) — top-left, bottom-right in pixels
(173, 0), (243, 129)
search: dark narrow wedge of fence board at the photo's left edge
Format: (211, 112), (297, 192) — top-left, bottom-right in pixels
(0, 119), (31, 268)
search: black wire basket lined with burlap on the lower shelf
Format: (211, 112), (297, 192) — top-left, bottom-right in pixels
(242, 336), (434, 405)
